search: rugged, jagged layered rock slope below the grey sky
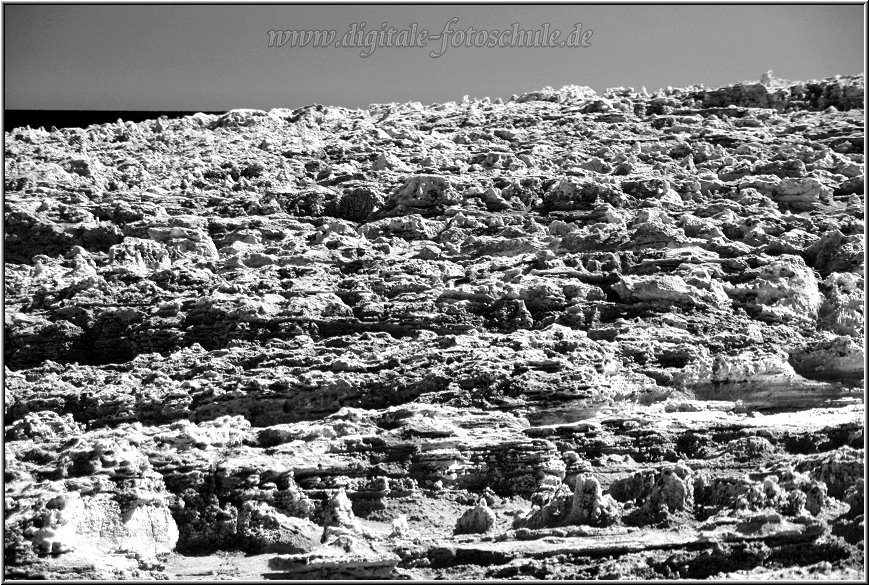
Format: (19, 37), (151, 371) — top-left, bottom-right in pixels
(4, 76), (865, 580)
